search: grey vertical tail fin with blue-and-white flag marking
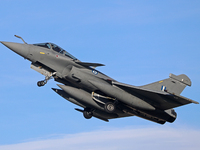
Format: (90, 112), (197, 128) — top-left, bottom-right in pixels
(142, 73), (191, 95)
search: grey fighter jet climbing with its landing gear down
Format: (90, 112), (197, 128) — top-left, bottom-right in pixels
(1, 35), (198, 124)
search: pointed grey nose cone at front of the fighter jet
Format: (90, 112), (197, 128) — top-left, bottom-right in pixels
(1, 41), (29, 58)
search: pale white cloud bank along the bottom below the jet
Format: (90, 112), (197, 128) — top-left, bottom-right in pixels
(0, 126), (200, 150)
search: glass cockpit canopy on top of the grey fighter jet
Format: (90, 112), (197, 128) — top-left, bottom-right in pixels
(33, 43), (77, 60)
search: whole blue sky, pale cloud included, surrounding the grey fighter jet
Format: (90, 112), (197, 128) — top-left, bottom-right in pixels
(0, 0), (200, 150)
